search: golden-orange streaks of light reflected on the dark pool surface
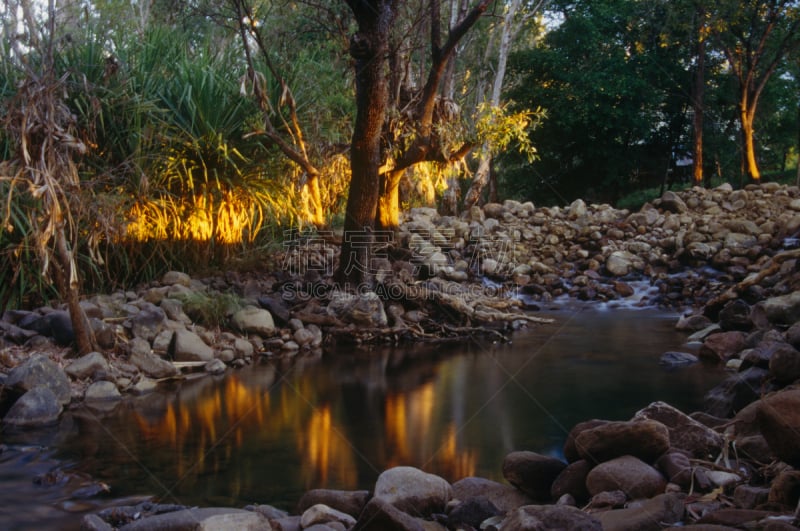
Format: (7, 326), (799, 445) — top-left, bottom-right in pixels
(135, 376), (477, 489)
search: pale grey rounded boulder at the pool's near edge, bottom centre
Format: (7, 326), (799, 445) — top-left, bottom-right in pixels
(374, 466), (453, 516)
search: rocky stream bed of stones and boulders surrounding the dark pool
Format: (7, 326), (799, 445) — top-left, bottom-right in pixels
(0, 183), (800, 530)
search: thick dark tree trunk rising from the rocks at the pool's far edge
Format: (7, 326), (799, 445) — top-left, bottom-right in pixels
(336, 0), (394, 289)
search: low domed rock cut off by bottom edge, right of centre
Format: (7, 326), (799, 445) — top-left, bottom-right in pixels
(502, 505), (603, 531)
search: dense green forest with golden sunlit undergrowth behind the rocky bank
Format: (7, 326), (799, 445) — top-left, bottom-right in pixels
(0, 0), (800, 314)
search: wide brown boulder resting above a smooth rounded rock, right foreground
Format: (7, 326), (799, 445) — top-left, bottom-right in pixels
(575, 419), (670, 463)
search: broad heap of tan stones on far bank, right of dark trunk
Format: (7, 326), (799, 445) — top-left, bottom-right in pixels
(406, 183), (800, 307)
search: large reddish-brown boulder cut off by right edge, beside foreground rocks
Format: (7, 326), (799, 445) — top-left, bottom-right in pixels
(756, 389), (800, 468)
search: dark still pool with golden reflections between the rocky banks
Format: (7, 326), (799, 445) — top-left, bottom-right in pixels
(0, 308), (724, 529)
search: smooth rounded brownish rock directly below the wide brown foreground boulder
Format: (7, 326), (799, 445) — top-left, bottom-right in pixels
(586, 455), (667, 499)
